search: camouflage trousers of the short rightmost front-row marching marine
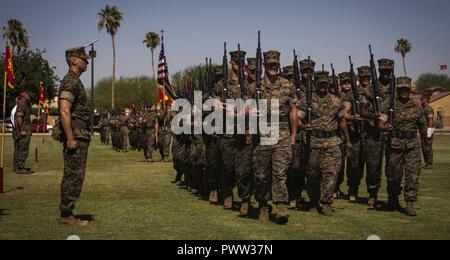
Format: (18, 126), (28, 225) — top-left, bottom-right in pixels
(387, 147), (421, 202)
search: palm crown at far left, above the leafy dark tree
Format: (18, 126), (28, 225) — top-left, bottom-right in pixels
(3, 19), (30, 53)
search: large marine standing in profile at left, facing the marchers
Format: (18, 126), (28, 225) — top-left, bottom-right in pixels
(59, 47), (91, 225)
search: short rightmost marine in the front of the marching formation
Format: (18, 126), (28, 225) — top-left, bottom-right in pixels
(379, 77), (427, 216)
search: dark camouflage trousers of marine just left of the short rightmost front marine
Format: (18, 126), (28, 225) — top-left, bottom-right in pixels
(360, 135), (384, 198)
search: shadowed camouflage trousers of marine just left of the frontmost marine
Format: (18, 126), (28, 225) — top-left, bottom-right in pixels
(236, 136), (255, 200)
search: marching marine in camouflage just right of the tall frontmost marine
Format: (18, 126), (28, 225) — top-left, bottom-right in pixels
(300, 71), (351, 216)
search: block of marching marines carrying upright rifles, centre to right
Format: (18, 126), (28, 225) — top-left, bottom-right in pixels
(168, 35), (434, 224)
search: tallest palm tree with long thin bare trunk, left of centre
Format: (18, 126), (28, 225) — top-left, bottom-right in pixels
(97, 5), (123, 109)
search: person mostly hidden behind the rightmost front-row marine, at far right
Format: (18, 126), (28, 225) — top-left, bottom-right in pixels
(421, 93), (434, 170)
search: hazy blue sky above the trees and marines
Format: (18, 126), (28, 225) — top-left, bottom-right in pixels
(0, 0), (450, 86)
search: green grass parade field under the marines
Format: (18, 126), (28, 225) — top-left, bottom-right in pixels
(0, 136), (450, 240)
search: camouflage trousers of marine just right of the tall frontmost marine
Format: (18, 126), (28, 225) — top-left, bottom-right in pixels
(308, 146), (342, 205)
